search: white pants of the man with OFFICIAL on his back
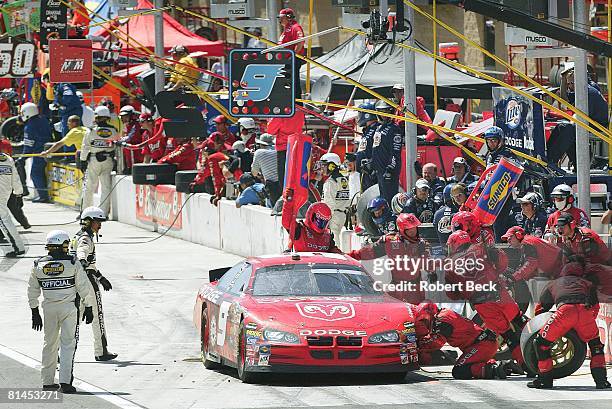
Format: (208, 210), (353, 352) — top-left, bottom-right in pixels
(41, 302), (79, 385)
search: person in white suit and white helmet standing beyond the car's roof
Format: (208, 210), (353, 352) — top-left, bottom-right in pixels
(319, 153), (350, 243)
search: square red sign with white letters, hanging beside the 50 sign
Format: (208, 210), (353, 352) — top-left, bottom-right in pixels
(49, 40), (93, 83)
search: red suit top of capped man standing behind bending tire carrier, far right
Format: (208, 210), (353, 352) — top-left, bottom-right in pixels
(559, 227), (610, 265)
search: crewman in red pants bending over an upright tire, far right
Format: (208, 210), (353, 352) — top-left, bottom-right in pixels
(527, 263), (610, 389)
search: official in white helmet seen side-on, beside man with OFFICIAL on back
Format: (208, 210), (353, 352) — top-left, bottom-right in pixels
(70, 207), (117, 361)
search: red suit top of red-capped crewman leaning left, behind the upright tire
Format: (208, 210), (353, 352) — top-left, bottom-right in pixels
(513, 235), (561, 281)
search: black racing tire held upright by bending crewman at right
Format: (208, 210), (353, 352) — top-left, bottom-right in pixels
(523, 330), (587, 379)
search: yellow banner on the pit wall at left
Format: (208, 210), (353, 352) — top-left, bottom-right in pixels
(47, 163), (83, 207)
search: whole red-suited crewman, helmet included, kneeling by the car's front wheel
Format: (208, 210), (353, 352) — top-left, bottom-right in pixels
(414, 302), (506, 379)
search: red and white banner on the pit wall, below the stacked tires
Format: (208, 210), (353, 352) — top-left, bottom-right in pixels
(136, 185), (183, 230)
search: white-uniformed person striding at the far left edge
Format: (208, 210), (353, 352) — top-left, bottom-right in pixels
(0, 153), (25, 258)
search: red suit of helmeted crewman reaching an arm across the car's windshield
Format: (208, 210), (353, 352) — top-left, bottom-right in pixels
(348, 233), (430, 305)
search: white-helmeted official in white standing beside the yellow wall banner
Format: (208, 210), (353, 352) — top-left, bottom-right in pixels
(81, 106), (119, 214)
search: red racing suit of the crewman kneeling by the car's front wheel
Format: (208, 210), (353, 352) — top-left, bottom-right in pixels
(415, 308), (497, 379)
